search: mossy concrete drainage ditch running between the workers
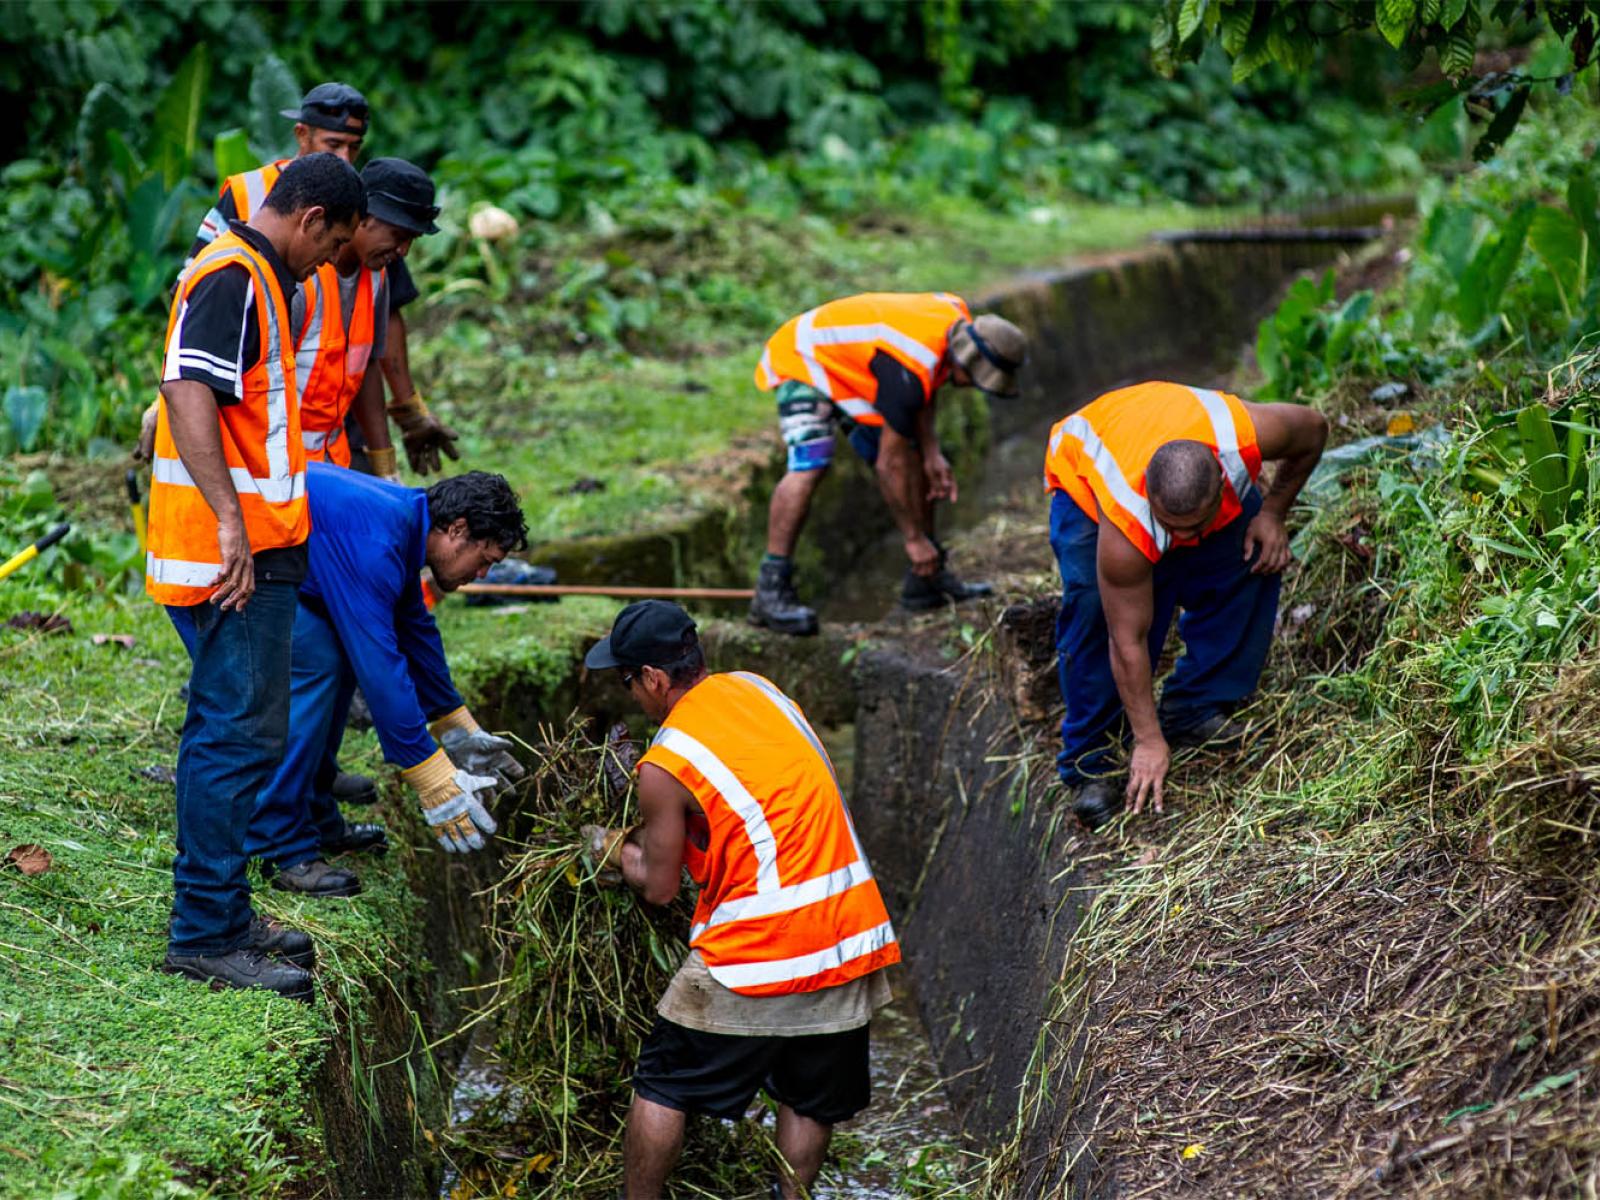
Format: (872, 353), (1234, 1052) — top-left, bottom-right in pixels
(320, 220), (1395, 1195)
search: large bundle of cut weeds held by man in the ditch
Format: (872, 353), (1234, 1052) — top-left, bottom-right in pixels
(446, 723), (773, 1200)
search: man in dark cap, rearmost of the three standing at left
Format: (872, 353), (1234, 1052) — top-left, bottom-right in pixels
(177, 83), (461, 478)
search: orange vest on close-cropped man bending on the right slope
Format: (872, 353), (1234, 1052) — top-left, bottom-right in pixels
(1045, 382), (1261, 563)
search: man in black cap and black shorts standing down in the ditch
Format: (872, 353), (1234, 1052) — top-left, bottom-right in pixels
(584, 611), (901, 1200)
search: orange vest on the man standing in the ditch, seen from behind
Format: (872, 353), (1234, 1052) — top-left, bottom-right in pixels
(640, 670), (901, 995)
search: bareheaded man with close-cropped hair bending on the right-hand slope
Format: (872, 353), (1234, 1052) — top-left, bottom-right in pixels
(1045, 382), (1328, 829)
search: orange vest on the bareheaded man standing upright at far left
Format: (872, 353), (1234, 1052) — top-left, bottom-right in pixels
(144, 234), (310, 605)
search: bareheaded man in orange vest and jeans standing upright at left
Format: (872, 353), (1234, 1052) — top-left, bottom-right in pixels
(146, 154), (366, 1000)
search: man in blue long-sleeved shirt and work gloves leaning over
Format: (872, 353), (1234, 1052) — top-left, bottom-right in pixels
(245, 462), (528, 896)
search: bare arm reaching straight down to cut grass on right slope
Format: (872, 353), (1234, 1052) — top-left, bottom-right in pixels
(1096, 512), (1171, 813)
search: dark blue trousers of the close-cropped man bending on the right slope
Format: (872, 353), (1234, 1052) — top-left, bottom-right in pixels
(1050, 490), (1283, 787)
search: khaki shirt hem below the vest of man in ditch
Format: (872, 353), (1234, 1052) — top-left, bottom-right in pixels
(656, 950), (894, 1037)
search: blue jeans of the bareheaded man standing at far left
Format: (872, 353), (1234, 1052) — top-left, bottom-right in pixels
(166, 579), (299, 955)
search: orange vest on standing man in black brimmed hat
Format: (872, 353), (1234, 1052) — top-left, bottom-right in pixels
(294, 262), (384, 467)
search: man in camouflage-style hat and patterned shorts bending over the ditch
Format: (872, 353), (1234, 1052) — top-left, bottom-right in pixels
(750, 291), (1027, 634)
